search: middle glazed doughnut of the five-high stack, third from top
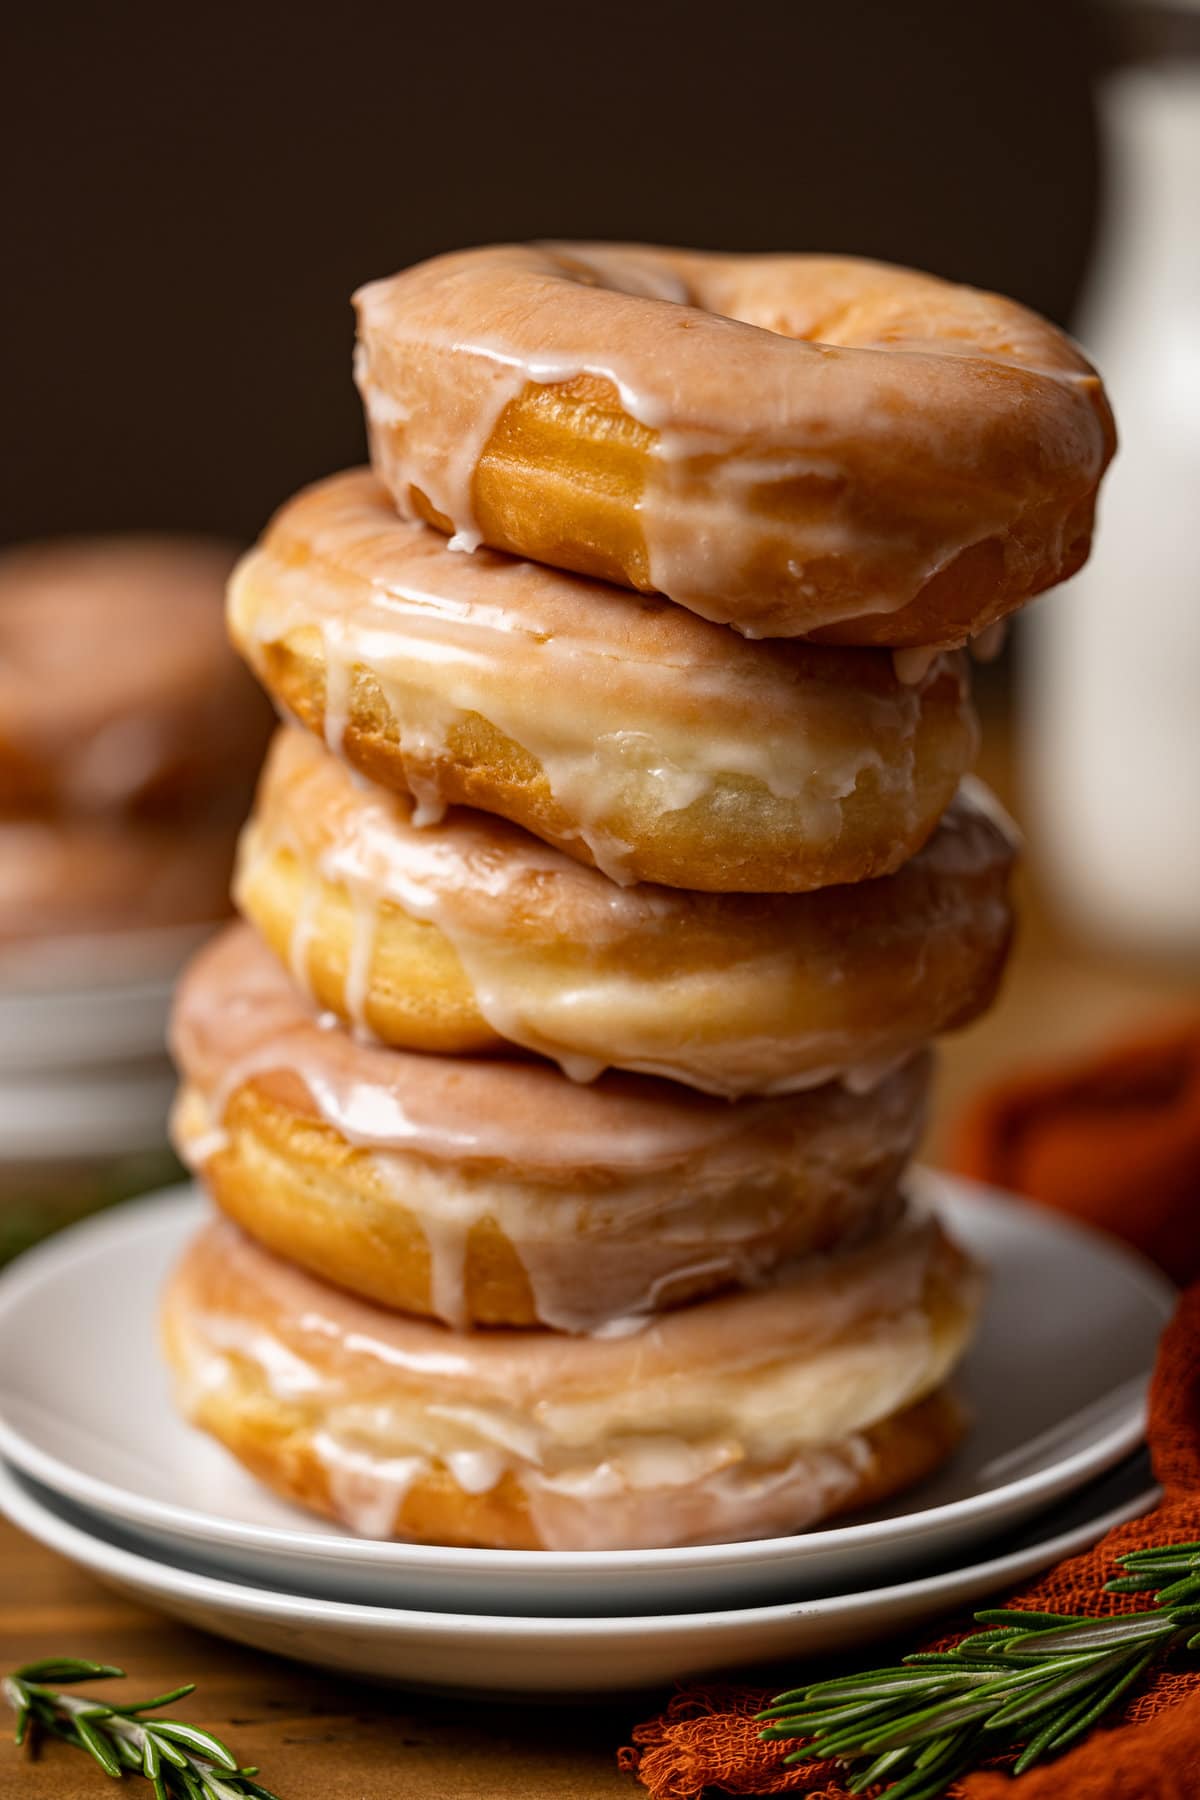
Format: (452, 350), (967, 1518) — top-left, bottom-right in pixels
(236, 731), (1013, 1094)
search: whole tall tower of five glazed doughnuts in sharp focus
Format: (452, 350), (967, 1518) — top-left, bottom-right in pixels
(164, 245), (1114, 1550)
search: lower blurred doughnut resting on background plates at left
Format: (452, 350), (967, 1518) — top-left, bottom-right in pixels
(0, 817), (237, 965)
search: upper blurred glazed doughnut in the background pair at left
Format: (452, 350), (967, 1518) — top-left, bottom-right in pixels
(0, 536), (270, 815)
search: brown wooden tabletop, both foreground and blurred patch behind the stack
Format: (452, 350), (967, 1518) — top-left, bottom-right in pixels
(0, 723), (1200, 1800)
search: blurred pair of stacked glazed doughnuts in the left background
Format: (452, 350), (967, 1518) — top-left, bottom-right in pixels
(0, 536), (268, 979)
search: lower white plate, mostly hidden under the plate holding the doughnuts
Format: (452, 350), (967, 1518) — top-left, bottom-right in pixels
(0, 1458), (1157, 1696)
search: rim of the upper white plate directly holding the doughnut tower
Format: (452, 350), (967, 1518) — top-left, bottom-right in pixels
(0, 1168), (1177, 1575)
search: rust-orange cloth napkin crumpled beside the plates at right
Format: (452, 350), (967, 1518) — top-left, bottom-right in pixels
(621, 1022), (1200, 1800)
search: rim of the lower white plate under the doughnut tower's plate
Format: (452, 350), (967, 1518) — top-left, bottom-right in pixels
(0, 1460), (1162, 1642)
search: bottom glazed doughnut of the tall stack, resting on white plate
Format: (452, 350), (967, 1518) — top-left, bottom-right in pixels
(164, 1219), (979, 1550)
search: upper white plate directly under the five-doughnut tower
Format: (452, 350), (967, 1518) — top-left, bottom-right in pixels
(0, 1177), (1171, 1615)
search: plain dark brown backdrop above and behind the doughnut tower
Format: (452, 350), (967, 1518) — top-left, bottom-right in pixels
(0, 0), (1097, 540)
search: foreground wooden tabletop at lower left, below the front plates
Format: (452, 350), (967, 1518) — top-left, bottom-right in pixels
(0, 1521), (636, 1800)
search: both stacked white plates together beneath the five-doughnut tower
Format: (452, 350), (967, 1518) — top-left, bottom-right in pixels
(0, 1175), (1173, 1694)
